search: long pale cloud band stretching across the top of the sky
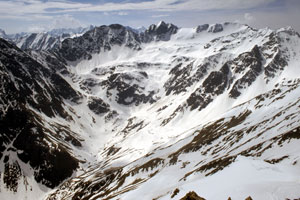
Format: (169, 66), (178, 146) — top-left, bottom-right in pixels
(0, 0), (276, 16)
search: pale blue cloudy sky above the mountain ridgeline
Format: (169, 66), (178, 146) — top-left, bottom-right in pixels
(0, 0), (300, 33)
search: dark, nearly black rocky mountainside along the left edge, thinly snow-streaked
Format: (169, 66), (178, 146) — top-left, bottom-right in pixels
(0, 39), (81, 191)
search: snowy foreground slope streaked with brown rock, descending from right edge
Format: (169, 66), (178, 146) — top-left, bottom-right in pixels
(49, 77), (300, 199)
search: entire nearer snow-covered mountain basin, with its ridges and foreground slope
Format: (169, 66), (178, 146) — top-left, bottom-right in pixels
(0, 22), (300, 200)
